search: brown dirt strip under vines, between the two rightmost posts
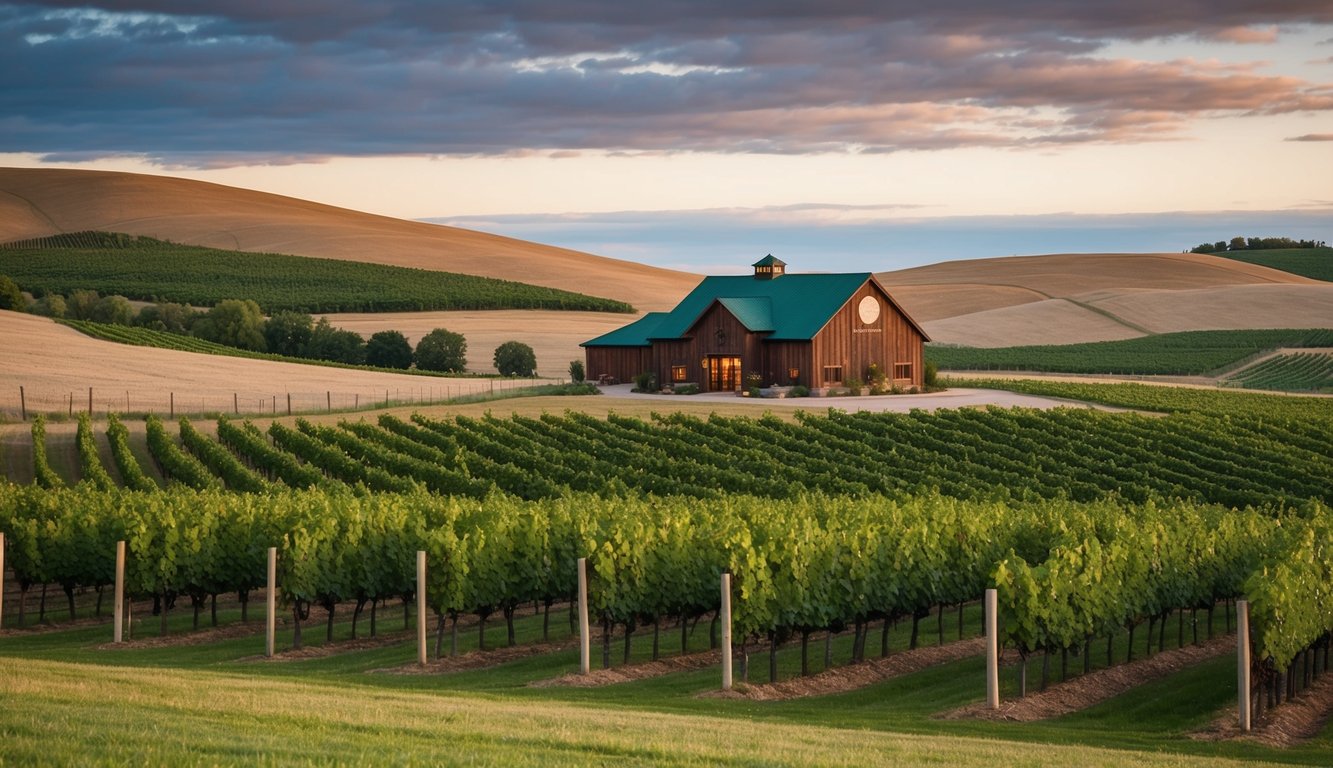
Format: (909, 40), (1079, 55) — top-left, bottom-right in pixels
(941, 635), (1236, 723)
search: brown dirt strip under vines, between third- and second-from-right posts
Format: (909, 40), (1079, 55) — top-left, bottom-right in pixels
(700, 637), (985, 701)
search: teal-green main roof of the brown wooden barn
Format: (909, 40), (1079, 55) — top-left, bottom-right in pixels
(647, 272), (870, 345)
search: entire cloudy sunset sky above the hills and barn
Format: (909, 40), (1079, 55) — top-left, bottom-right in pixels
(0, 0), (1333, 271)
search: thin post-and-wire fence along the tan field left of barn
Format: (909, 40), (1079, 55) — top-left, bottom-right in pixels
(0, 379), (551, 420)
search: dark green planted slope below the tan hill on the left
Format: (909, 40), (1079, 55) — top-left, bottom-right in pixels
(0, 232), (633, 313)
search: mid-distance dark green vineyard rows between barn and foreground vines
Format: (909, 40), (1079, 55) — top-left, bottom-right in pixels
(83, 408), (1333, 508)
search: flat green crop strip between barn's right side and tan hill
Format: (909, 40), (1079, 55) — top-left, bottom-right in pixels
(925, 328), (1333, 376)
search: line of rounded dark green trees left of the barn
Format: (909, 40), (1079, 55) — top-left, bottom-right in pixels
(0, 275), (537, 376)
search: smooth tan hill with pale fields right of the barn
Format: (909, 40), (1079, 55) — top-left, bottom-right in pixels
(878, 253), (1333, 347)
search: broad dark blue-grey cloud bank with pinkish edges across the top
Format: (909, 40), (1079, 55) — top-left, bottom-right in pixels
(0, 0), (1333, 165)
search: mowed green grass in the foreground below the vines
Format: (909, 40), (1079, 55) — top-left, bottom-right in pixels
(0, 605), (1333, 767)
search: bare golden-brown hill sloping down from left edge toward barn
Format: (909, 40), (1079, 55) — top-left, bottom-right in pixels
(0, 168), (698, 311)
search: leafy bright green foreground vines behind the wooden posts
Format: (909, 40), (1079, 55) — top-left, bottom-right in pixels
(0, 485), (1333, 680)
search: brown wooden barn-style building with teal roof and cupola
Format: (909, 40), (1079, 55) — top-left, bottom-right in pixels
(581, 256), (929, 392)
